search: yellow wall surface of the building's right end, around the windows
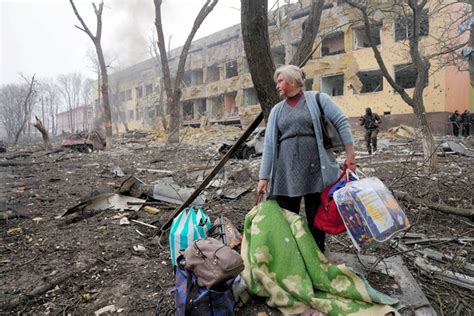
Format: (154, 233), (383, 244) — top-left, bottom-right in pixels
(304, 1), (469, 117)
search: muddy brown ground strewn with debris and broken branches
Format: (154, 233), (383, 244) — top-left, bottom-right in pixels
(0, 129), (474, 315)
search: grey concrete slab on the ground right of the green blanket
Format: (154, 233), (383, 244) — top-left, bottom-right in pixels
(327, 253), (437, 316)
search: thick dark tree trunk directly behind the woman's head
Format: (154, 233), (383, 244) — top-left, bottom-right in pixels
(241, 0), (280, 121)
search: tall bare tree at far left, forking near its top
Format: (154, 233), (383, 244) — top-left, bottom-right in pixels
(69, 0), (112, 148)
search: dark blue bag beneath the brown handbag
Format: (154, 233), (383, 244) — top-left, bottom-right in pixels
(175, 264), (236, 316)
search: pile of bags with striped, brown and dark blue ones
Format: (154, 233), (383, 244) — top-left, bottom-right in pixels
(169, 207), (246, 316)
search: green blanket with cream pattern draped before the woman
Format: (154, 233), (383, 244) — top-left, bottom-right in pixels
(241, 200), (400, 316)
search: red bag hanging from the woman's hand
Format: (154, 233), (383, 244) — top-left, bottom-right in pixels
(313, 170), (349, 235)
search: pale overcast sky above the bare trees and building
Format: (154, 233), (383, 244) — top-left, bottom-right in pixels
(0, 0), (244, 85)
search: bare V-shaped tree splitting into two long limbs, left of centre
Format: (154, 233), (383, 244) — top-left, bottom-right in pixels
(154, 0), (218, 143)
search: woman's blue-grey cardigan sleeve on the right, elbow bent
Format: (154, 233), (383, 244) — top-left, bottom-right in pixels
(320, 92), (353, 145)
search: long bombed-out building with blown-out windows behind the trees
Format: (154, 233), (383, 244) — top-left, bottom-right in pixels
(93, 0), (469, 133)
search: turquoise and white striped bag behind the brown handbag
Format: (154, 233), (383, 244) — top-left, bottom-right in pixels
(169, 206), (212, 266)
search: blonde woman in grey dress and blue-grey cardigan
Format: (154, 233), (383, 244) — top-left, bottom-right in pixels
(257, 65), (356, 252)
